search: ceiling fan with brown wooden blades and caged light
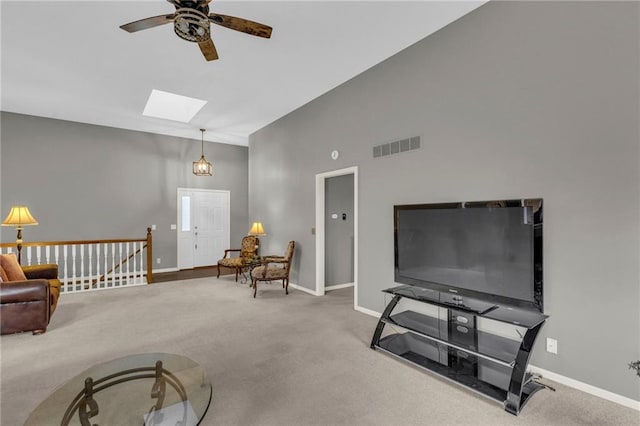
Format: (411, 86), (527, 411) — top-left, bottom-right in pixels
(120, 0), (272, 61)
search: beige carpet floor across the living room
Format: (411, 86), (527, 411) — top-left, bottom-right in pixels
(0, 276), (640, 426)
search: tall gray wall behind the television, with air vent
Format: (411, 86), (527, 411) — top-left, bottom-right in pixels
(249, 2), (640, 400)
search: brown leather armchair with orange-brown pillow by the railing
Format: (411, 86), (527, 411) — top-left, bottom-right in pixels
(0, 264), (60, 334)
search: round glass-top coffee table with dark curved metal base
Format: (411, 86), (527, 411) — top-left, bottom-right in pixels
(25, 353), (212, 426)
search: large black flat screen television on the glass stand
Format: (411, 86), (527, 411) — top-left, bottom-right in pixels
(393, 198), (543, 312)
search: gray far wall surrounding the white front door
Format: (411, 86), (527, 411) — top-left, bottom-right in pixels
(0, 112), (249, 268)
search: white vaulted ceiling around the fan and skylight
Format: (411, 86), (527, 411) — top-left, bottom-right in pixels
(0, 0), (485, 145)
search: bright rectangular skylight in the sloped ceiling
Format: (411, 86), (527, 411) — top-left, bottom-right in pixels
(142, 89), (207, 123)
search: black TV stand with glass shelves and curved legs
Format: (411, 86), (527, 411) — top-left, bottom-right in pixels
(371, 286), (547, 415)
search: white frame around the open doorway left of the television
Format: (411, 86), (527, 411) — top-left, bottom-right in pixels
(315, 166), (358, 309)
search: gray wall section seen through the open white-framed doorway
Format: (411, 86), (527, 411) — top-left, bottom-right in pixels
(324, 174), (354, 287)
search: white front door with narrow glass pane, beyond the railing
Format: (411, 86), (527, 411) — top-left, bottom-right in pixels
(177, 188), (230, 269)
